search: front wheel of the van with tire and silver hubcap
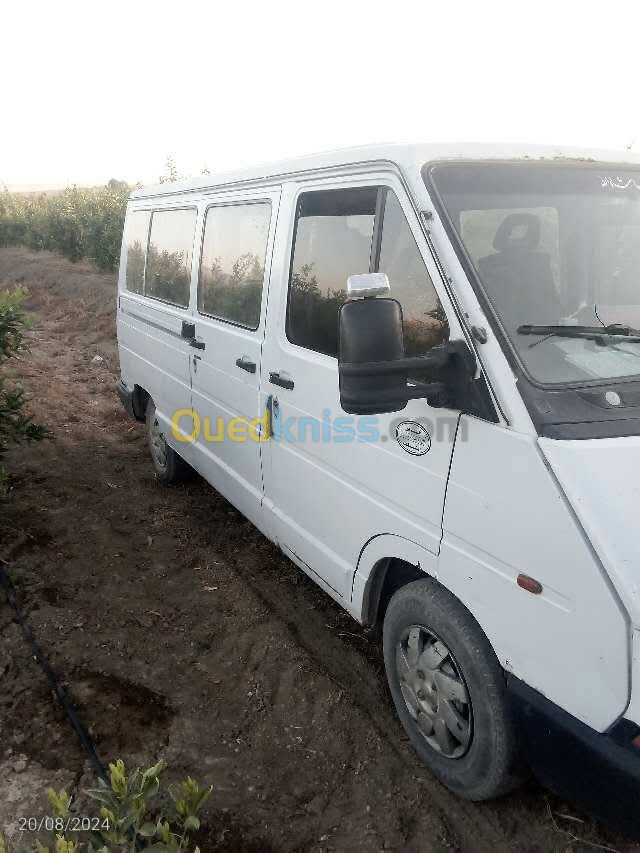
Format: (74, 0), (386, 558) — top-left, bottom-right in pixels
(383, 578), (522, 800)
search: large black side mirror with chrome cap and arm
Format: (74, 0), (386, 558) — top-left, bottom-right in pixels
(338, 273), (475, 415)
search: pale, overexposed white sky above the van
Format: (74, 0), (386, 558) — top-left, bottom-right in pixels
(0, 0), (640, 189)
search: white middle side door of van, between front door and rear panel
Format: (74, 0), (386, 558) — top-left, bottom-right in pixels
(191, 190), (279, 529)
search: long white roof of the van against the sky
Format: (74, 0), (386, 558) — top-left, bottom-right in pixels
(131, 143), (640, 198)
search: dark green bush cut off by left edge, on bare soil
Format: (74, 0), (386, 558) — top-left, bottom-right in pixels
(0, 287), (46, 482)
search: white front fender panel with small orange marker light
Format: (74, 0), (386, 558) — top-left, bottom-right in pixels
(438, 416), (630, 731)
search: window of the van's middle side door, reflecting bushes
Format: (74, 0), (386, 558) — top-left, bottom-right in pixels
(198, 202), (271, 329)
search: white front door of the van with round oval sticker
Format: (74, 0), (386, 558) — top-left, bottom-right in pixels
(262, 176), (459, 599)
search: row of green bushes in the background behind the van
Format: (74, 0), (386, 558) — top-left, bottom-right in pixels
(0, 180), (131, 270)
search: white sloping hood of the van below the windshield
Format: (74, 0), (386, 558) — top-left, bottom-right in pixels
(539, 436), (640, 627)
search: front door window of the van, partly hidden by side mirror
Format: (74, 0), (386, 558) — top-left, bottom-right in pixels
(286, 187), (449, 357)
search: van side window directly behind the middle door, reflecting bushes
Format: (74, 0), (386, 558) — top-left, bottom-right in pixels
(145, 208), (197, 308)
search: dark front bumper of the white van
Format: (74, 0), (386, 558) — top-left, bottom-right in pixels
(507, 675), (640, 839)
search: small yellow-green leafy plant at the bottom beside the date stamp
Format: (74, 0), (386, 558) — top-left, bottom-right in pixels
(26, 760), (211, 853)
